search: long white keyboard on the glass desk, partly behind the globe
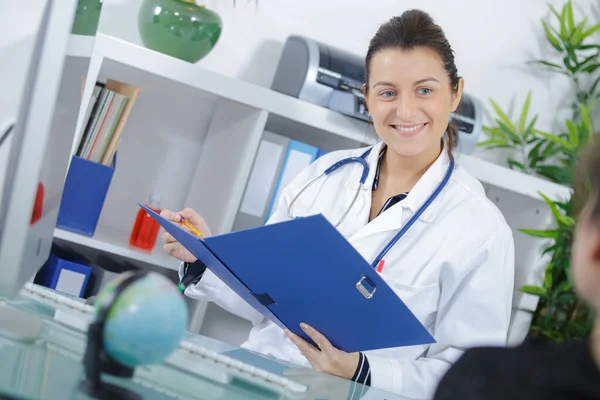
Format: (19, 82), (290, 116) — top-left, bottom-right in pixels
(23, 283), (308, 394)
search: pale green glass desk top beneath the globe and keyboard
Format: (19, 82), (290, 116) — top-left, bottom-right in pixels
(0, 291), (404, 400)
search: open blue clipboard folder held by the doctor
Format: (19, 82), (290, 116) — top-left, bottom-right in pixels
(140, 204), (435, 353)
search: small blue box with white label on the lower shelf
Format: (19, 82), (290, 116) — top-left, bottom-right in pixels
(35, 252), (92, 297)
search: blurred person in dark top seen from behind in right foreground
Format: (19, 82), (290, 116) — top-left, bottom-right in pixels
(435, 135), (600, 400)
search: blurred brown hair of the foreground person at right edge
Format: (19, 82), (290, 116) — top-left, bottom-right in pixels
(574, 134), (600, 223)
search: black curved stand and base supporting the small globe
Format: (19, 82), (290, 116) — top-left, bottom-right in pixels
(79, 272), (145, 400)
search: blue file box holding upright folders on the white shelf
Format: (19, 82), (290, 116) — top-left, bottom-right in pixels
(56, 156), (115, 236)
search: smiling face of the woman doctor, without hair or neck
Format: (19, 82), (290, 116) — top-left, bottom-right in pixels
(364, 47), (463, 156)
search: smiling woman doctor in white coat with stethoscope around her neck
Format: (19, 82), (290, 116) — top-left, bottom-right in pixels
(163, 10), (514, 398)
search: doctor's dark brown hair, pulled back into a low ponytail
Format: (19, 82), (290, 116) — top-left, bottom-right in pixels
(365, 10), (460, 152)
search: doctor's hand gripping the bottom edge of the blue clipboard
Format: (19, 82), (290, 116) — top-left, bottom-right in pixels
(285, 324), (360, 379)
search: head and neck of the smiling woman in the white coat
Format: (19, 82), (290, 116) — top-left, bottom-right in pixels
(363, 10), (464, 219)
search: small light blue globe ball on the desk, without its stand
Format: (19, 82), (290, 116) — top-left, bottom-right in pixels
(96, 272), (188, 368)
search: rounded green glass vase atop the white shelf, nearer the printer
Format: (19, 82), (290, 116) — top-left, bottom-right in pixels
(138, 0), (223, 63)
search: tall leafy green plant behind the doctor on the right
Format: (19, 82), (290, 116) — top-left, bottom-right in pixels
(479, 0), (600, 342)
